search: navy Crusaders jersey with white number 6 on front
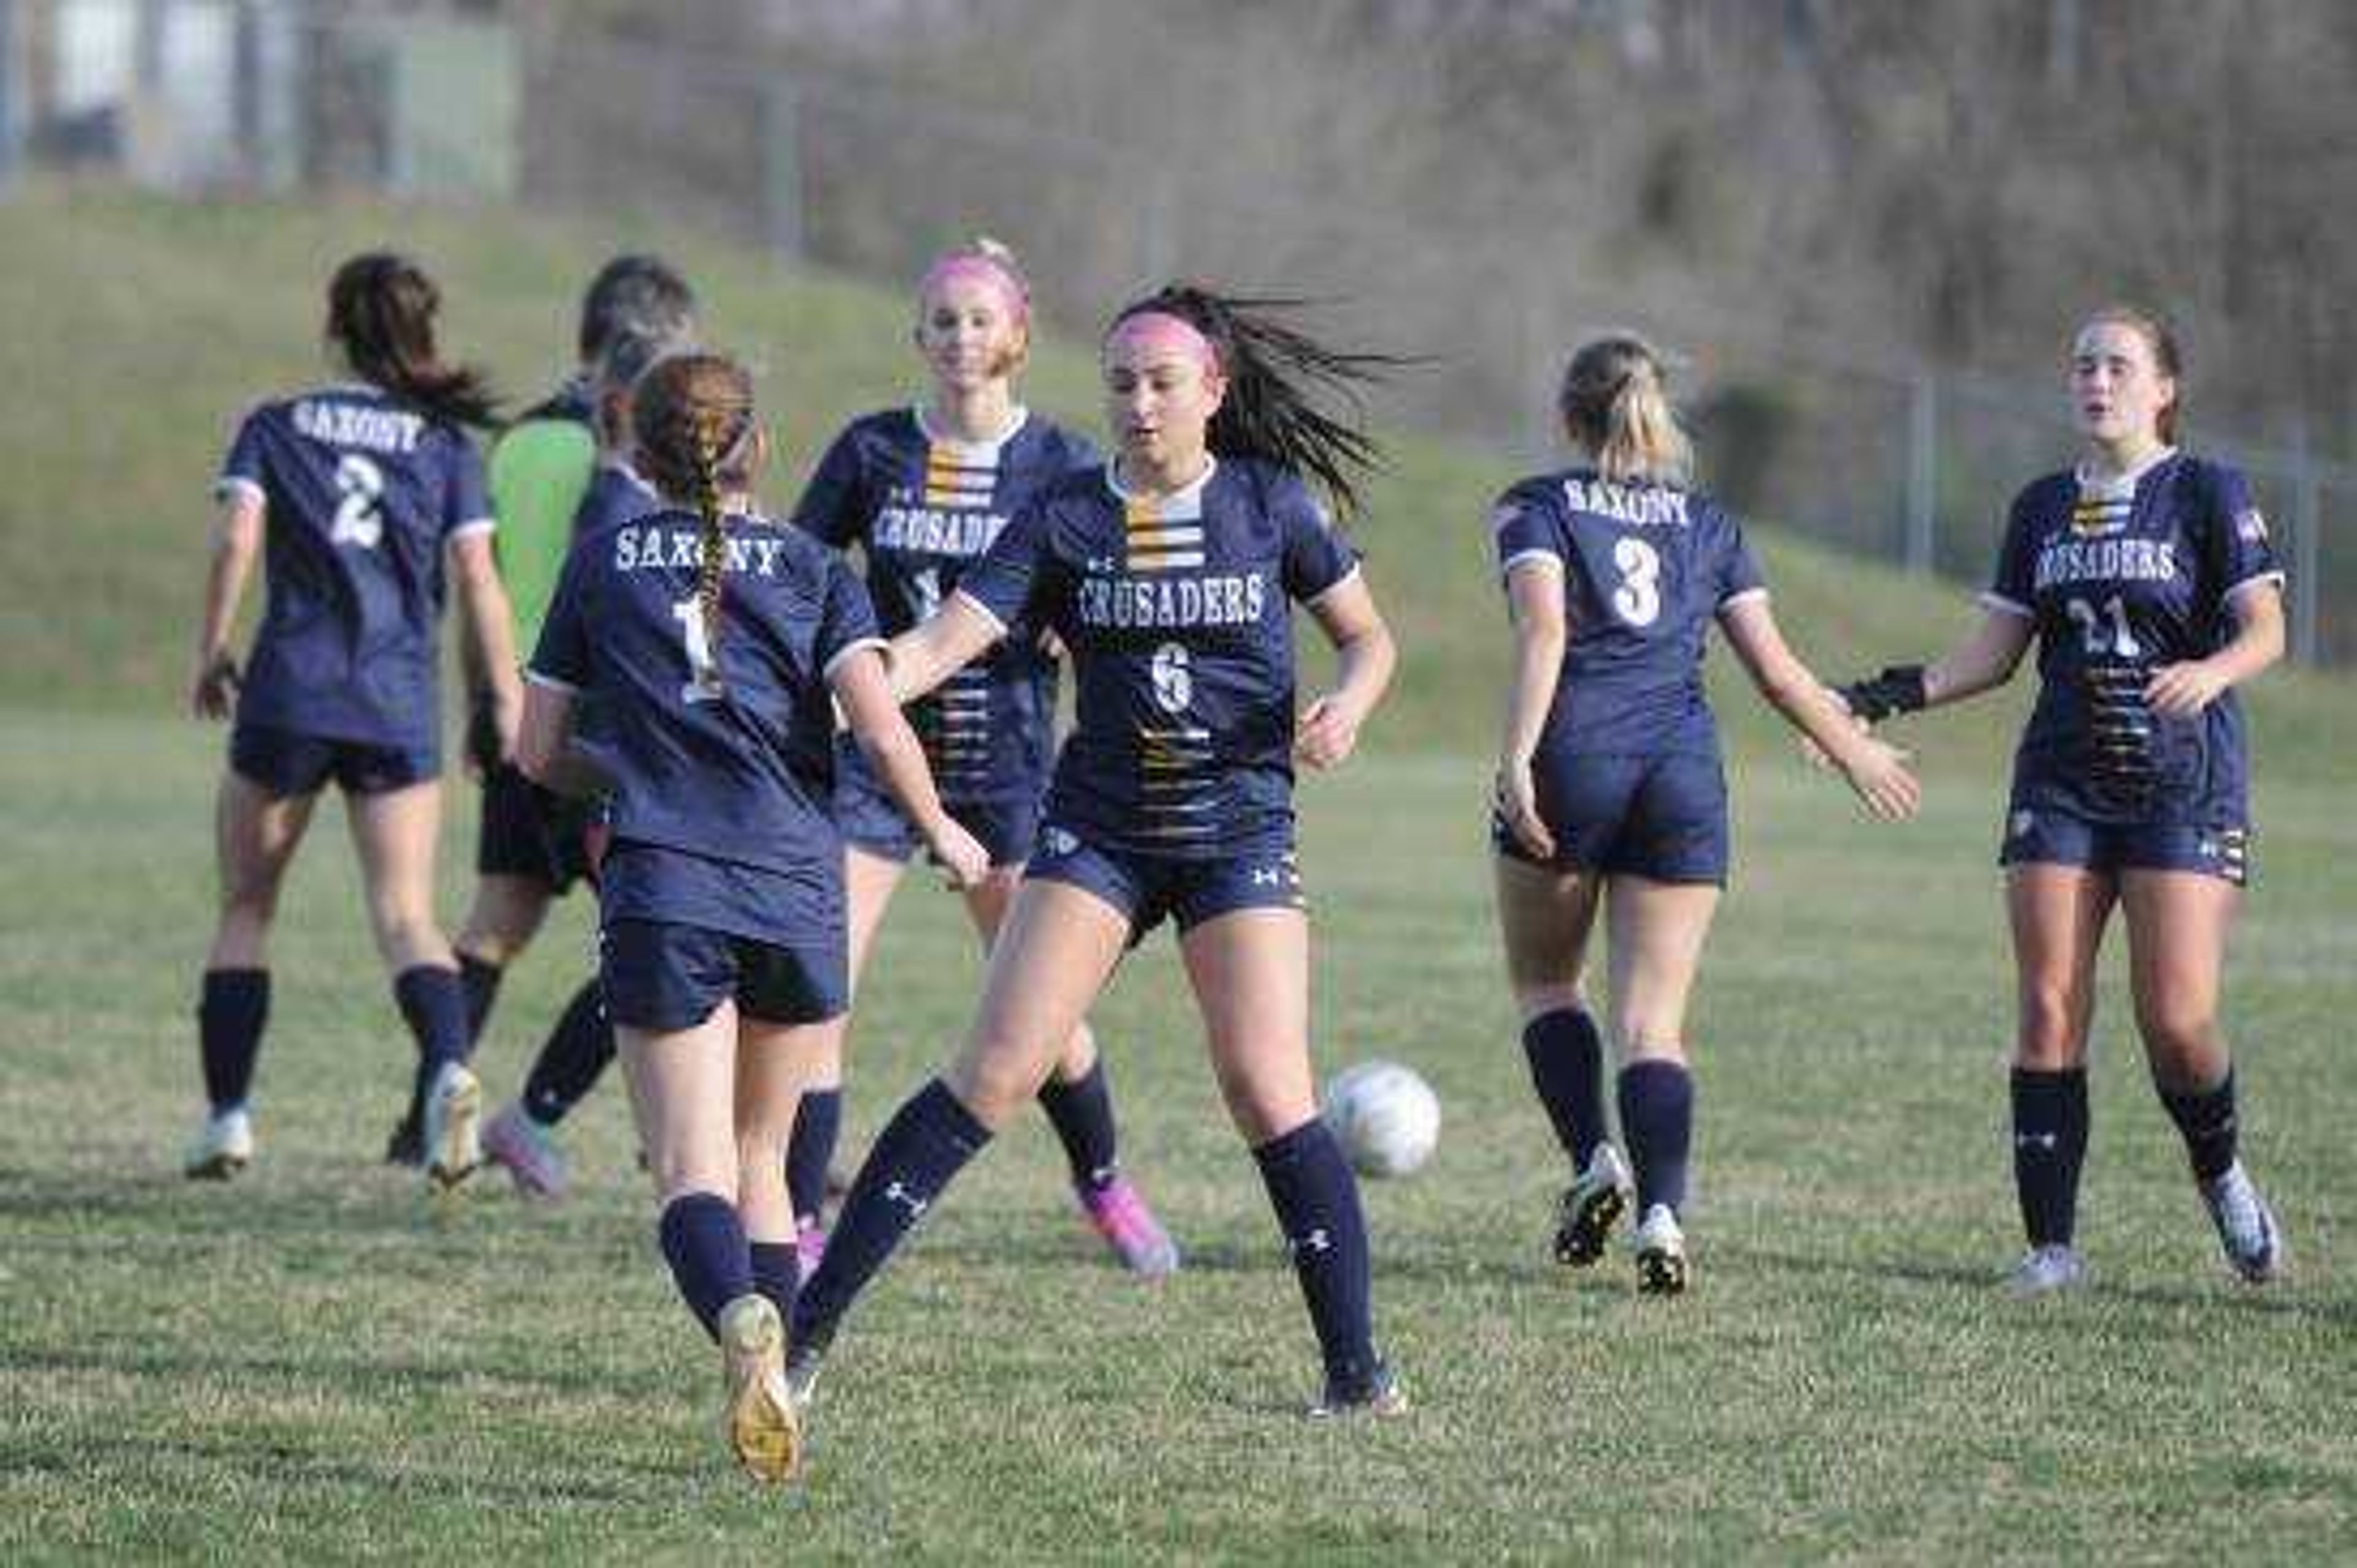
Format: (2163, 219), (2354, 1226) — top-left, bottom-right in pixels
(959, 460), (1358, 859)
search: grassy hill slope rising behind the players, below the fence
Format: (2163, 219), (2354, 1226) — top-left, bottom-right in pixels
(0, 187), (2357, 773)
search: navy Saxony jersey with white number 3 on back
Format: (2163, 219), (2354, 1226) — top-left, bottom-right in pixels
(1490, 469), (1768, 757)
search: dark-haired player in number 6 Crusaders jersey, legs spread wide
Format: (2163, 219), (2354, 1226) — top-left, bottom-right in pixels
(792, 288), (1405, 1415)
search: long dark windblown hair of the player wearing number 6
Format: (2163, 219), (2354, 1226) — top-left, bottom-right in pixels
(1108, 283), (1409, 516)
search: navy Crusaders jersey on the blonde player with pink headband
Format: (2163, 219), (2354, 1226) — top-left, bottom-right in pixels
(794, 408), (1096, 804)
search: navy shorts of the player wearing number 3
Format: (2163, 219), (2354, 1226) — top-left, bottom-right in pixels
(1490, 752), (1728, 887)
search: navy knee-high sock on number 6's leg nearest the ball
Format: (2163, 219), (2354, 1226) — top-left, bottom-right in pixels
(1252, 1118), (1374, 1391)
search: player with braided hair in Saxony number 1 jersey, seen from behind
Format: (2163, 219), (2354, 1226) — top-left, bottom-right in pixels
(519, 353), (988, 1481)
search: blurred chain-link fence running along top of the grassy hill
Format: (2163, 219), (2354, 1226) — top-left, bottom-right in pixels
(0, 0), (2357, 663)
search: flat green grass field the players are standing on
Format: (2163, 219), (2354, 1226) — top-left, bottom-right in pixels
(0, 709), (2357, 1561)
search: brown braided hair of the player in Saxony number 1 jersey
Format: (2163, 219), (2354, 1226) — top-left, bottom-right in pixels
(632, 351), (754, 684)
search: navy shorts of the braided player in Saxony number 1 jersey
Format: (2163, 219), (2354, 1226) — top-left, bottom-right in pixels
(598, 919), (851, 1033)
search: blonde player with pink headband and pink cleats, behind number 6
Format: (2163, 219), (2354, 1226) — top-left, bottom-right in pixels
(788, 241), (1178, 1278)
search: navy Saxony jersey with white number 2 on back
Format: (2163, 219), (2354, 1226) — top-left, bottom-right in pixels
(214, 384), (493, 750)
